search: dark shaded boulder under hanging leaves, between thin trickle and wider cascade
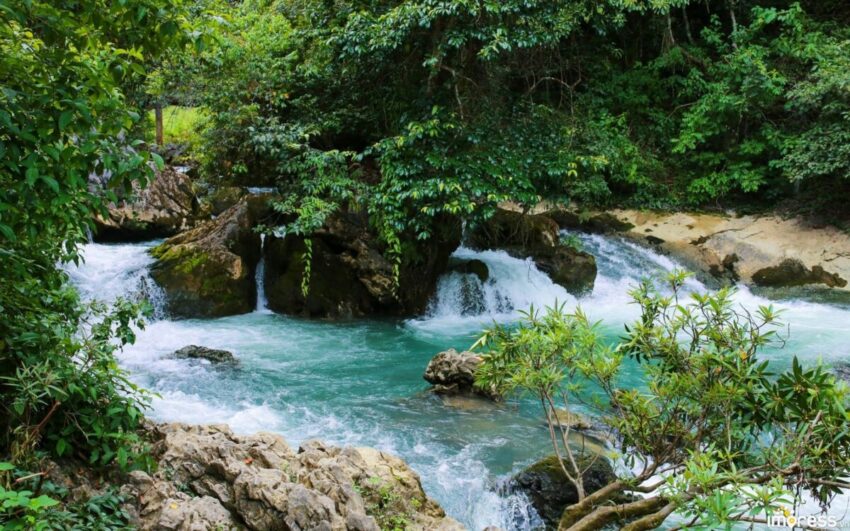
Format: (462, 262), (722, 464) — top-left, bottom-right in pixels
(264, 212), (460, 317)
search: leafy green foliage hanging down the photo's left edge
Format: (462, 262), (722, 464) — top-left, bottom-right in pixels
(0, 0), (198, 474)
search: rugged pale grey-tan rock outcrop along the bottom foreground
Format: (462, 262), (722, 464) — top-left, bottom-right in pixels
(122, 424), (463, 531)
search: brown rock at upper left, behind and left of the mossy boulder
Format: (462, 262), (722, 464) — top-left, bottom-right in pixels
(94, 166), (199, 241)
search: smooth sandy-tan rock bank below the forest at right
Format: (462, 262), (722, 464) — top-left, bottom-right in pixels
(555, 210), (850, 291)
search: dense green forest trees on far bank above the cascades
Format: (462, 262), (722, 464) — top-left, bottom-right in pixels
(181, 0), (850, 239)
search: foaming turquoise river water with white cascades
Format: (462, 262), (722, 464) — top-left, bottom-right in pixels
(64, 235), (850, 529)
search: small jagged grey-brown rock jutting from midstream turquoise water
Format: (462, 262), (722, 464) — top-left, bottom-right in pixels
(424, 348), (501, 400)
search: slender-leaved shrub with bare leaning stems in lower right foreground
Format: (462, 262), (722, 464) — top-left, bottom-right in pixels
(476, 273), (850, 531)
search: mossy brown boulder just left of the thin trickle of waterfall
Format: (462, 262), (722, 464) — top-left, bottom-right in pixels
(151, 198), (264, 317)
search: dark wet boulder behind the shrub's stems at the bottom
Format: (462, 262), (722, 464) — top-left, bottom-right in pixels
(508, 455), (616, 529)
